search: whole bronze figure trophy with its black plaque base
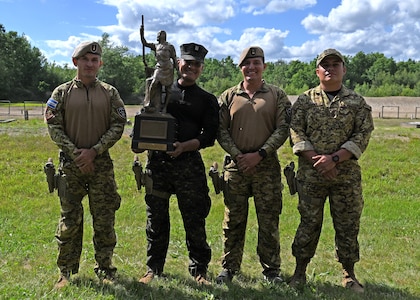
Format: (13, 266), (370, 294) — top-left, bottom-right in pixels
(131, 16), (177, 152)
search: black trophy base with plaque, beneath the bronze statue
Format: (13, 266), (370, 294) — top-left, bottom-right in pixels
(131, 112), (177, 152)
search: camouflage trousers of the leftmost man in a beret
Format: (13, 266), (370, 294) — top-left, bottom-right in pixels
(55, 153), (121, 274)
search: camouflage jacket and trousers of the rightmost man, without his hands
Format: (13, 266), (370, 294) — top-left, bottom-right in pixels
(290, 86), (374, 263)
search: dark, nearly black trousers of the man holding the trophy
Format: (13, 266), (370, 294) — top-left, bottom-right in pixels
(145, 151), (211, 276)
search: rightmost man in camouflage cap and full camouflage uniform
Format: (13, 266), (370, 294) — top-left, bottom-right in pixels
(290, 49), (374, 292)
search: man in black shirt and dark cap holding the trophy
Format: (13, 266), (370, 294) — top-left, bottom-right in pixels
(139, 43), (219, 285)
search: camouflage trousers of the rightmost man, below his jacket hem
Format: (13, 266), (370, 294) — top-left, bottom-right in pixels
(292, 168), (364, 264)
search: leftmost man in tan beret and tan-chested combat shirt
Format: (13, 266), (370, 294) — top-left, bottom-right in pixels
(45, 42), (126, 288)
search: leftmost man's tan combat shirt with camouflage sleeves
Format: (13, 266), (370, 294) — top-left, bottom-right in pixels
(45, 79), (127, 159)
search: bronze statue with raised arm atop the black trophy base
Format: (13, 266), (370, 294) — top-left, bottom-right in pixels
(140, 24), (177, 113)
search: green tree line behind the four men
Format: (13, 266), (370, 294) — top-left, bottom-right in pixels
(0, 24), (420, 104)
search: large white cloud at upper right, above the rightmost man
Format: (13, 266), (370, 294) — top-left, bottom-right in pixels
(298, 0), (420, 60)
